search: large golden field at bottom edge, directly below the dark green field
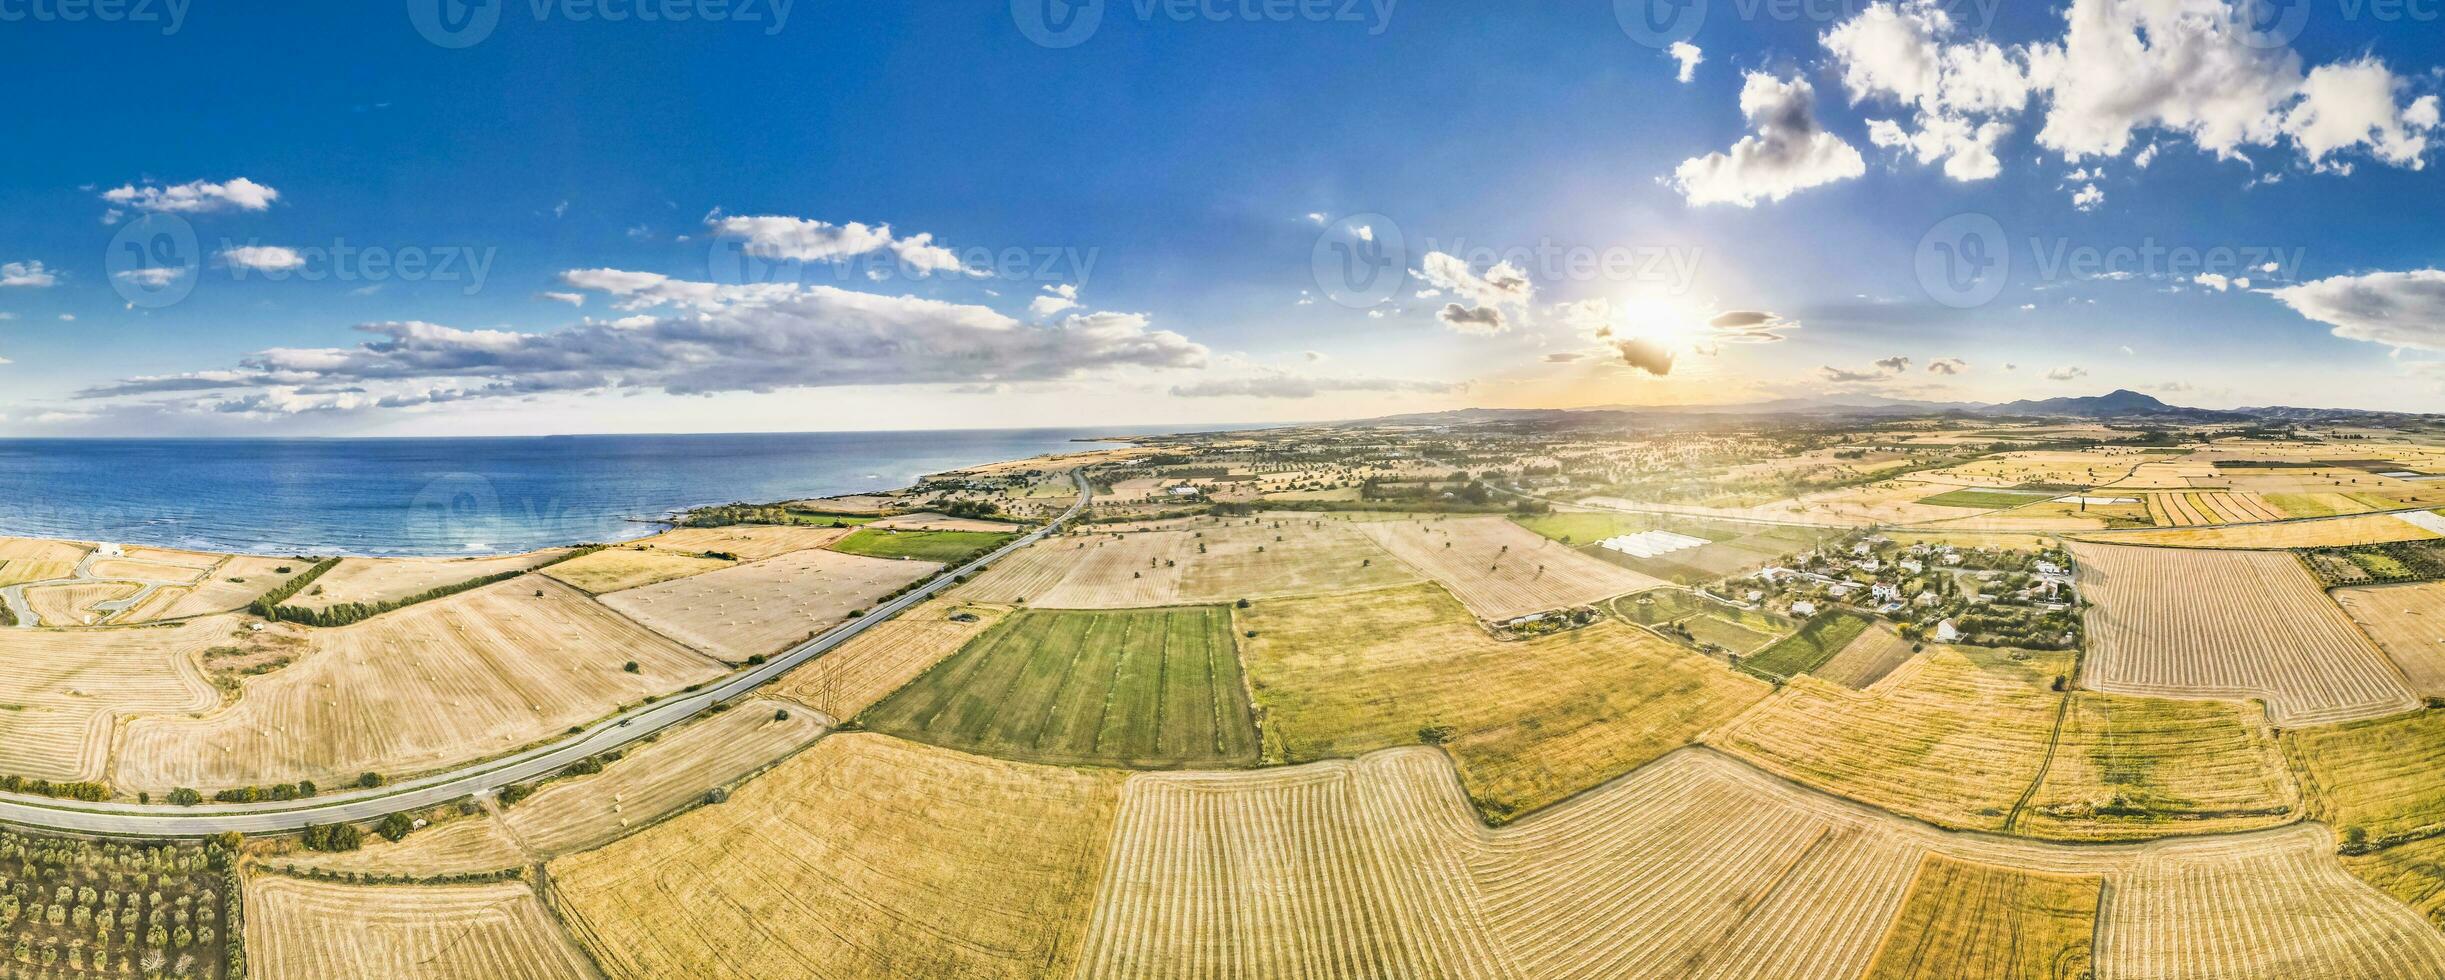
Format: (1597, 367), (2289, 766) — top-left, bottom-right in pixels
(550, 733), (1122, 980)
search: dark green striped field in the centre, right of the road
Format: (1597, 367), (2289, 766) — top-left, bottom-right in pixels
(858, 606), (1257, 767)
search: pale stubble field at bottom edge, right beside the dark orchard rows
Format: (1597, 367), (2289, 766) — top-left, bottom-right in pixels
(247, 875), (594, 980)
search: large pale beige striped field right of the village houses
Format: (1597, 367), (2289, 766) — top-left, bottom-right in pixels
(2071, 545), (2421, 728)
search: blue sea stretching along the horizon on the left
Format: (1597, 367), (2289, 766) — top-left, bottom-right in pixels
(0, 430), (1110, 555)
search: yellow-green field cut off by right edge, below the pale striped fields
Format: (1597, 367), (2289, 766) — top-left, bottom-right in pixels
(2284, 709), (2445, 846)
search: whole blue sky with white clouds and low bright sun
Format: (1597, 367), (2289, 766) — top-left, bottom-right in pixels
(0, 0), (2445, 435)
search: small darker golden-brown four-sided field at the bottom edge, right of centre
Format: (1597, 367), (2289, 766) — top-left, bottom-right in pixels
(1866, 853), (2105, 980)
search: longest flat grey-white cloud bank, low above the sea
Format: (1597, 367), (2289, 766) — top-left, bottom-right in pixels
(81, 269), (1208, 415)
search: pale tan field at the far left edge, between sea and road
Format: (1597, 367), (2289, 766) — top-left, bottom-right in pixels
(0, 616), (237, 780)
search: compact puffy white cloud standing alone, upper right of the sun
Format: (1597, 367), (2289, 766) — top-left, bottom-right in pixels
(1672, 71), (1868, 208)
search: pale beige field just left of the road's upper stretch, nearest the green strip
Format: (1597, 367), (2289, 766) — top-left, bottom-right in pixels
(601, 550), (941, 662)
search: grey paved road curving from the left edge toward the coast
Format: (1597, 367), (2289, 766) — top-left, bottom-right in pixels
(0, 474), (1095, 836)
